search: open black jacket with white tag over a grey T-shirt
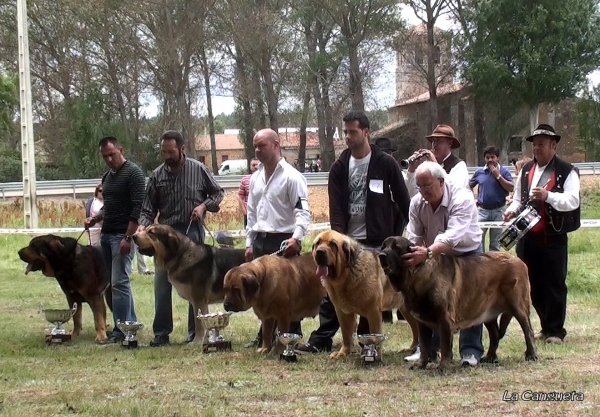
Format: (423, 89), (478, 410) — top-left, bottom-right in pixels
(328, 146), (410, 246)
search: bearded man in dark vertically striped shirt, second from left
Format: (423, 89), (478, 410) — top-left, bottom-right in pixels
(137, 130), (224, 347)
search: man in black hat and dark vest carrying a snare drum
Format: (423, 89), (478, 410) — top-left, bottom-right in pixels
(503, 124), (580, 344)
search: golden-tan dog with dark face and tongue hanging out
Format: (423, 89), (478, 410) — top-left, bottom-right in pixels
(312, 230), (418, 358)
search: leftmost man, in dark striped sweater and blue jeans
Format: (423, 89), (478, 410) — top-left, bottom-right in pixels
(85, 136), (146, 344)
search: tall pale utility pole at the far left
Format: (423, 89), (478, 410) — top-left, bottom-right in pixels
(17, 0), (38, 229)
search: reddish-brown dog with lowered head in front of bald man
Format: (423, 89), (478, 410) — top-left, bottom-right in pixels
(223, 253), (327, 353)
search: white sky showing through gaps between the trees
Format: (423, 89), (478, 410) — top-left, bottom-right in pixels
(144, 5), (600, 117)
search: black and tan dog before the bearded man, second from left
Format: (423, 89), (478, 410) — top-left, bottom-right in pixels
(133, 224), (245, 343)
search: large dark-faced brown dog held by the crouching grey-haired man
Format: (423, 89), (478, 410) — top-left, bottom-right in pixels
(380, 237), (537, 370)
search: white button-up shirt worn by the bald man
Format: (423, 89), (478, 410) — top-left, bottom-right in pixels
(246, 158), (310, 247)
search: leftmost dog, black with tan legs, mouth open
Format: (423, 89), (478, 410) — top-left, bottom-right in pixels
(19, 235), (112, 342)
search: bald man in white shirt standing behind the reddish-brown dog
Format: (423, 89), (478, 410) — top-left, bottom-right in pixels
(246, 129), (310, 347)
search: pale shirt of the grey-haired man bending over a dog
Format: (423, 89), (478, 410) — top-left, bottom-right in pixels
(406, 182), (482, 255)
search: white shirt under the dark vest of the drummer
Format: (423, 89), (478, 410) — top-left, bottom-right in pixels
(506, 164), (581, 213)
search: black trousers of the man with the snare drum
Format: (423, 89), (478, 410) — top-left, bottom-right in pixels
(517, 232), (568, 339)
